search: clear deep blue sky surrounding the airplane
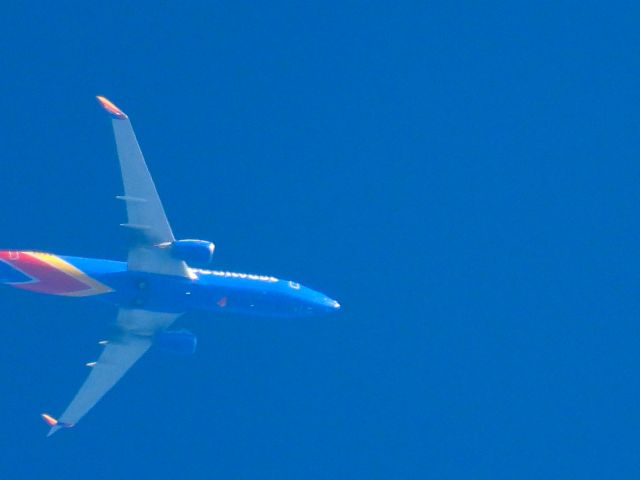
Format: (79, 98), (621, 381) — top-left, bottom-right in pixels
(0, 2), (640, 479)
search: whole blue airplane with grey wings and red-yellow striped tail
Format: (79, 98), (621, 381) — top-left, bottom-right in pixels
(0, 96), (340, 436)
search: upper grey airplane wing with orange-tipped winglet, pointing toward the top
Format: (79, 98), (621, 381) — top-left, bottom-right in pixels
(96, 96), (190, 278)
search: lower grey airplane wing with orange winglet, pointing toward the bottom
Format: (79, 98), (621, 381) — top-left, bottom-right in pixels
(43, 309), (182, 436)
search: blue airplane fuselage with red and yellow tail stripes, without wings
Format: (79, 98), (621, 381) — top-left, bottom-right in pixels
(0, 250), (340, 317)
